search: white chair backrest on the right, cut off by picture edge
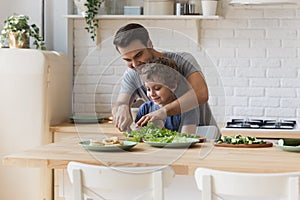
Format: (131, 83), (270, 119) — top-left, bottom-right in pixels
(195, 168), (300, 200)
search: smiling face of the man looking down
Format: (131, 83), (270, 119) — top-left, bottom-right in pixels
(118, 40), (153, 70)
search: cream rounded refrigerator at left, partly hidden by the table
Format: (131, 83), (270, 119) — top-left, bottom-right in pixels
(0, 48), (71, 200)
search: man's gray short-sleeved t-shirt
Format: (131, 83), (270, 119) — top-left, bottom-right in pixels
(120, 52), (220, 136)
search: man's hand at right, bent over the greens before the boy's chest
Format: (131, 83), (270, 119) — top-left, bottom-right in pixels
(136, 107), (167, 126)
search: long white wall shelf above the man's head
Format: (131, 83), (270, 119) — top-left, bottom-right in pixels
(65, 15), (223, 20)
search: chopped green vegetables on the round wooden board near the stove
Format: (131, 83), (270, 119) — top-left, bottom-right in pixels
(217, 135), (266, 144)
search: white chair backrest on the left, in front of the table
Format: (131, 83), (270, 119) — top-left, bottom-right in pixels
(67, 162), (175, 200)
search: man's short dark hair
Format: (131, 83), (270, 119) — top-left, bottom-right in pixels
(113, 23), (149, 50)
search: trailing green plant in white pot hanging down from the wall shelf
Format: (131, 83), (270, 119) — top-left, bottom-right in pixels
(74, 0), (104, 41)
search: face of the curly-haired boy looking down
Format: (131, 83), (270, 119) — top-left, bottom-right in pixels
(145, 81), (176, 107)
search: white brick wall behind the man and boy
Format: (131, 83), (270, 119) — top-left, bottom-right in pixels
(73, 1), (300, 125)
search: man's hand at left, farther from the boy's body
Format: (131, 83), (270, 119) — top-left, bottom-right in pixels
(113, 104), (133, 132)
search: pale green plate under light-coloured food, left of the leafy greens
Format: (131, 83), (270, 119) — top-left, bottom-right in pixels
(79, 141), (137, 151)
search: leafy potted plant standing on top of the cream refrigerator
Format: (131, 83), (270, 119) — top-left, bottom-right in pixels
(1, 15), (46, 50)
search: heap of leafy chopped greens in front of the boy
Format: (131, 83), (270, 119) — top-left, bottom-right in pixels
(124, 122), (199, 143)
